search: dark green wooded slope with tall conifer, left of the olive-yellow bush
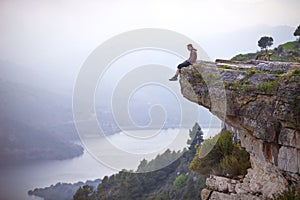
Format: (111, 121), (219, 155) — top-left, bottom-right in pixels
(74, 124), (206, 200)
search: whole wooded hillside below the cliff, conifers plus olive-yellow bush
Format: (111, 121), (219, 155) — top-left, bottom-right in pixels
(74, 123), (250, 200)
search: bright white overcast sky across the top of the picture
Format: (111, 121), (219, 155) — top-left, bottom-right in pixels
(0, 0), (300, 69)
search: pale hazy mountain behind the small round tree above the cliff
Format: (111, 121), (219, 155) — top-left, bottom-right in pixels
(198, 25), (296, 60)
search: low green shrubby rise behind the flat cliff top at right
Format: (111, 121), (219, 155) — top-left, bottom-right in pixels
(231, 41), (300, 62)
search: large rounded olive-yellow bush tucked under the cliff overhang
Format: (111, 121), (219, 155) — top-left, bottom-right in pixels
(190, 131), (250, 178)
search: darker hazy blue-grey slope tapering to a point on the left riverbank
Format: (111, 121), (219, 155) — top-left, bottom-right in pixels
(0, 118), (83, 167)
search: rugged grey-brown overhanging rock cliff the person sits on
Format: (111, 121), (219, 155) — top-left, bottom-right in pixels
(180, 60), (300, 199)
